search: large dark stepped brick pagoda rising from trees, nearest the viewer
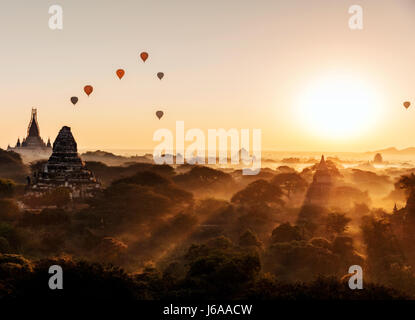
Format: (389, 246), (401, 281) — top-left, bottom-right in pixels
(30, 126), (100, 198)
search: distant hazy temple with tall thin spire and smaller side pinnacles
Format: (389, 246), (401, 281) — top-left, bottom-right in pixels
(7, 108), (52, 160)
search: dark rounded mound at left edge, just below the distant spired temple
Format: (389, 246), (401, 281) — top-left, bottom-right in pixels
(0, 149), (30, 183)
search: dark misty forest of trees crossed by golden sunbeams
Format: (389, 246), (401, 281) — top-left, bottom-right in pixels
(0, 151), (415, 299)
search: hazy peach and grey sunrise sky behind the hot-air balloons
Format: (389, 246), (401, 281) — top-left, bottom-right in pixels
(0, 0), (415, 151)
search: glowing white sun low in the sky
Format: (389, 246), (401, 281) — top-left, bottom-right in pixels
(299, 75), (377, 139)
